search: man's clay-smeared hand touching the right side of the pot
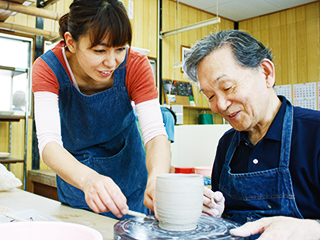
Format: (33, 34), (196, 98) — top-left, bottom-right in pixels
(202, 187), (224, 217)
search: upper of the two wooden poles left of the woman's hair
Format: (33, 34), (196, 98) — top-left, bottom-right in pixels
(0, 1), (62, 20)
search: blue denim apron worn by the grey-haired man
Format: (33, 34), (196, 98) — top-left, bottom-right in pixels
(219, 102), (303, 238)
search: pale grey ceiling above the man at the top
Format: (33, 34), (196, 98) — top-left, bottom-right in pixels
(179, 0), (315, 22)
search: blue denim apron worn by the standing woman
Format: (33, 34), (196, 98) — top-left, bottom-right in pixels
(41, 50), (150, 218)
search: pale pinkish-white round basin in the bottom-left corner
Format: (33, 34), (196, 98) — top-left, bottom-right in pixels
(0, 221), (103, 240)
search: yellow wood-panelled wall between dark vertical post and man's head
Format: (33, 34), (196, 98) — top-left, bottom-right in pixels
(162, 0), (234, 124)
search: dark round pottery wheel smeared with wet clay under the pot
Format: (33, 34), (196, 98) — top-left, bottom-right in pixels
(113, 215), (240, 240)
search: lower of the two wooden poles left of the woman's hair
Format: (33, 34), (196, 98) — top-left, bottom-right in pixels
(0, 22), (59, 39)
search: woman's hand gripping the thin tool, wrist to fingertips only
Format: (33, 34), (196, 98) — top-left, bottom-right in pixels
(83, 172), (129, 218)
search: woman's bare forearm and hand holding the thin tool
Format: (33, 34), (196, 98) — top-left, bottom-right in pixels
(43, 142), (128, 217)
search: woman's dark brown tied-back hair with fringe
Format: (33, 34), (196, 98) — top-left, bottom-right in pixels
(59, 0), (132, 47)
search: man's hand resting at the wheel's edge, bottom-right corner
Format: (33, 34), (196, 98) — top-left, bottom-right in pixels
(230, 216), (320, 240)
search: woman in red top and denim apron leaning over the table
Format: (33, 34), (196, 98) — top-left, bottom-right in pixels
(32, 0), (170, 218)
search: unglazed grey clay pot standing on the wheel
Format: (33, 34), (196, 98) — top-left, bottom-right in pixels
(156, 173), (204, 231)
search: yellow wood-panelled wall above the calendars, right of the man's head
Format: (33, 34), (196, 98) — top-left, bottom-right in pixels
(239, 1), (320, 85)
